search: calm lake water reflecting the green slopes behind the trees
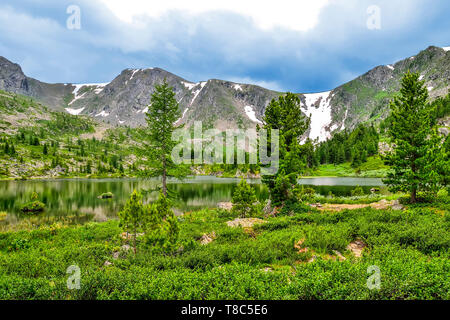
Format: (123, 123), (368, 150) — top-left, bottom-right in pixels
(0, 177), (382, 221)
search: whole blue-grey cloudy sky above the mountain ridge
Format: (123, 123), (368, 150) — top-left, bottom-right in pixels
(0, 0), (450, 92)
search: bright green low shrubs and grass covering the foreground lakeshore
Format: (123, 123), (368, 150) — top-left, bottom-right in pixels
(0, 205), (450, 300)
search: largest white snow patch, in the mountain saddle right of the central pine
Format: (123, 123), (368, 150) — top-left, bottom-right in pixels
(303, 91), (332, 142)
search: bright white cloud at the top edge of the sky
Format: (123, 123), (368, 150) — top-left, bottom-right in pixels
(101, 0), (329, 31)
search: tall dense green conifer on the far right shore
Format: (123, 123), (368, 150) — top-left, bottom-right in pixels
(384, 72), (440, 203)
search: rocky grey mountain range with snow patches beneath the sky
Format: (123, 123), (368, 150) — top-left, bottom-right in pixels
(0, 46), (450, 141)
